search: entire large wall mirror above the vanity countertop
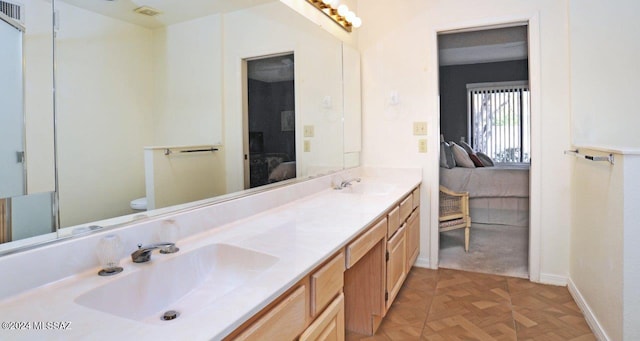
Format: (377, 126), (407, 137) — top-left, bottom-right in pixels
(0, 0), (360, 252)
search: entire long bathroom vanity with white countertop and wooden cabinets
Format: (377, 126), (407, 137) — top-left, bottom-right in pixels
(0, 169), (421, 340)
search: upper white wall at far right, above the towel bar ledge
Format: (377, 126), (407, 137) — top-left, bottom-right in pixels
(569, 0), (640, 148)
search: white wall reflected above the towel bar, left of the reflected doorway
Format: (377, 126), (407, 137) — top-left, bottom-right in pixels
(153, 15), (223, 146)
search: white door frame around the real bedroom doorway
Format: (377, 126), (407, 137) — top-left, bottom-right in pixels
(428, 12), (542, 282)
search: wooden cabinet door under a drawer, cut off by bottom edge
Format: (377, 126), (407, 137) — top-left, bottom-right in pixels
(300, 294), (345, 341)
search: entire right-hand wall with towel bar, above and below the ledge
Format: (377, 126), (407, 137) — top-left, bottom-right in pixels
(569, 0), (640, 340)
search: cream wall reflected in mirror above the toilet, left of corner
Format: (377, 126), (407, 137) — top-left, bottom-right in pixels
(56, 2), (153, 226)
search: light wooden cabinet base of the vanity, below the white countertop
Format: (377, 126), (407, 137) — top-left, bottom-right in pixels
(225, 185), (420, 340)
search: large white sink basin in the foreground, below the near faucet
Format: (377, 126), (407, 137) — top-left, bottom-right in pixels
(75, 244), (278, 324)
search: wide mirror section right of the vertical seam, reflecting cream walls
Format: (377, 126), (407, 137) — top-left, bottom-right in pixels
(56, 0), (343, 227)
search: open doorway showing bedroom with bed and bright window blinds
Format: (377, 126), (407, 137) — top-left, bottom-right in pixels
(437, 23), (531, 278)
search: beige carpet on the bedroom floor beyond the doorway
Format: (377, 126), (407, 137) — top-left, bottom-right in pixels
(439, 224), (529, 278)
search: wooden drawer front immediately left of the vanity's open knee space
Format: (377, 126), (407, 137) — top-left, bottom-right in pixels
(311, 252), (344, 316)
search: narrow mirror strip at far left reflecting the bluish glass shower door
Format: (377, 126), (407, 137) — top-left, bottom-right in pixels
(0, 0), (54, 246)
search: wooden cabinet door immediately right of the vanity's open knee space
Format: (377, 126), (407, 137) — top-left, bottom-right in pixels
(385, 224), (407, 310)
